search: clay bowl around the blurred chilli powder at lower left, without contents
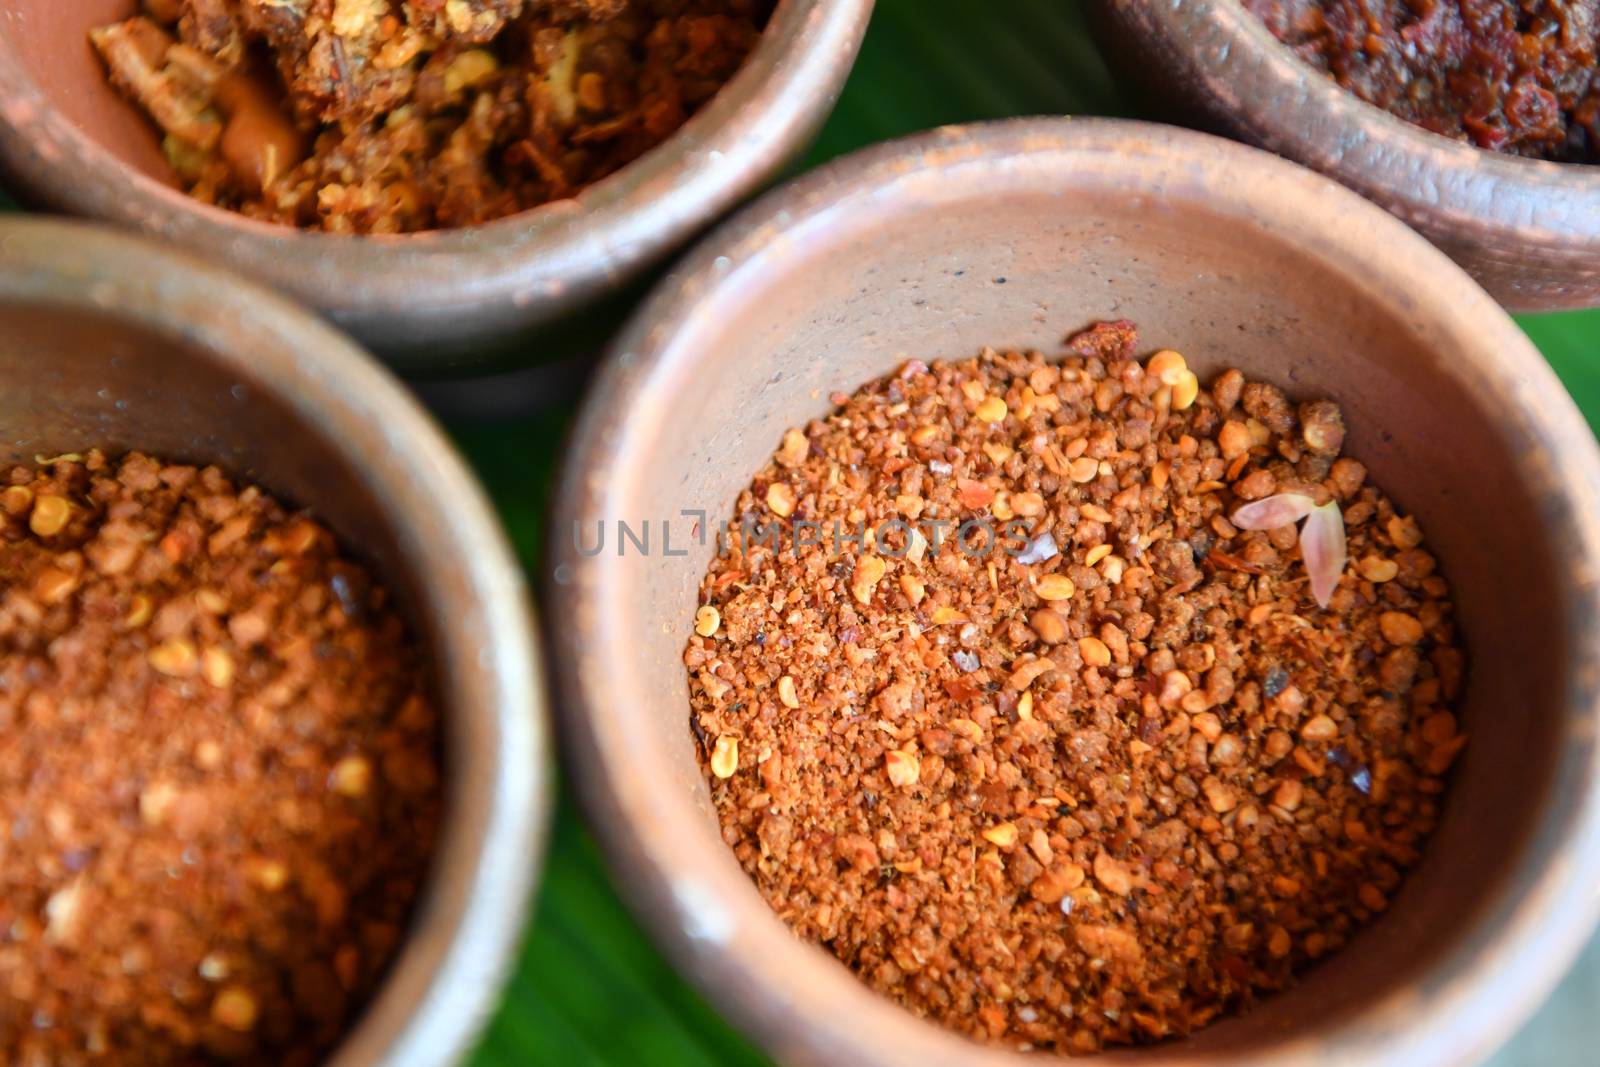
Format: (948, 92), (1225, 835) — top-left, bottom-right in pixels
(0, 219), (549, 1067)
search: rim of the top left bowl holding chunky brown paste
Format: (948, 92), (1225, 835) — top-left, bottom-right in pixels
(0, 0), (872, 342)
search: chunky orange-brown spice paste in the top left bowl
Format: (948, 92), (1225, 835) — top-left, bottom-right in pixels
(90, 0), (773, 234)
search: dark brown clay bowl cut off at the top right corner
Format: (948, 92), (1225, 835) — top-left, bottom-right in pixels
(1090, 0), (1600, 312)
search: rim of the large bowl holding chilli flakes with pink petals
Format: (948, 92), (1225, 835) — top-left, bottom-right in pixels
(547, 118), (1600, 1067)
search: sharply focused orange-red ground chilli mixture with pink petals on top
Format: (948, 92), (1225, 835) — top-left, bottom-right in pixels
(683, 322), (1466, 1053)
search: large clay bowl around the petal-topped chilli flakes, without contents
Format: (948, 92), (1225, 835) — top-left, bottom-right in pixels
(549, 120), (1600, 1067)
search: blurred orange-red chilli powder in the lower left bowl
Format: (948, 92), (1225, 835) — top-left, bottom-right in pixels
(0, 453), (440, 1067)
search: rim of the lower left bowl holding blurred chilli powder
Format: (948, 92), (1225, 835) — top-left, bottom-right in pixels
(0, 216), (550, 1067)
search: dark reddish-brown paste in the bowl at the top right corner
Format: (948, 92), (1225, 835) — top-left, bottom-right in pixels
(1243, 0), (1600, 163)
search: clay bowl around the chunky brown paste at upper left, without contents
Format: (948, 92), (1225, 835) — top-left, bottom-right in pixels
(0, 0), (872, 373)
